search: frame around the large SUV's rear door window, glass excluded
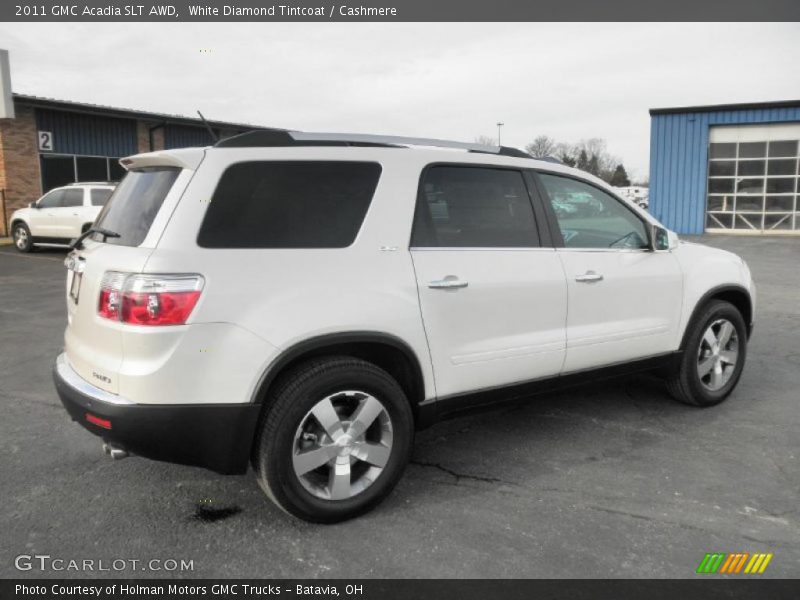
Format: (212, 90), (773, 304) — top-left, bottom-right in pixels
(408, 161), (555, 252)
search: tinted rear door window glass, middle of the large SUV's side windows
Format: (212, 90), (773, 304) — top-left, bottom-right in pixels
(411, 166), (539, 248)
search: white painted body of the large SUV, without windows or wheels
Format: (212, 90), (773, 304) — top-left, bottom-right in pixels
(59, 147), (754, 412)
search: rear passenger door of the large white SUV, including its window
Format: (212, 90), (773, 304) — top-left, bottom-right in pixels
(411, 165), (567, 398)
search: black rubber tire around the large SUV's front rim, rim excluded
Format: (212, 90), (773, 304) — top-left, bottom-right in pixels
(681, 301), (747, 406)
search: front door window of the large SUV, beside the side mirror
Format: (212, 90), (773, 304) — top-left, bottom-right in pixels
(539, 173), (647, 248)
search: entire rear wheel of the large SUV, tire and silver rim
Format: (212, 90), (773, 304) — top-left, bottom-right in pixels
(253, 357), (414, 523)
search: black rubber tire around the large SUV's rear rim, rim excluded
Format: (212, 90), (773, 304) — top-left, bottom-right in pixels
(259, 366), (414, 523)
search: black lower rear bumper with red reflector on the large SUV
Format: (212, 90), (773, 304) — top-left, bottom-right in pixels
(53, 354), (260, 474)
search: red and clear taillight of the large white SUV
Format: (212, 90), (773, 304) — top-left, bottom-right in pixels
(97, 271), (204, 325)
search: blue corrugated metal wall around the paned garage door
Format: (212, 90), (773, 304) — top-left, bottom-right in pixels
(650, 106), (800, 234)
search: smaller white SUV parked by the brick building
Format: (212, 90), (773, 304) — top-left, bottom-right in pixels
(9, 182), (115, 252)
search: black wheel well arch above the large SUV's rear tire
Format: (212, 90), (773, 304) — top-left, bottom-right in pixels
(255, 340), (432, 417)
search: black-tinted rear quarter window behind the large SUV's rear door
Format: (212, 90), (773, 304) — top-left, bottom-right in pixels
(197, 161), (381, 248)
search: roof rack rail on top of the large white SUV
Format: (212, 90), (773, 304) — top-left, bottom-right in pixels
(214, 129), (531, 158)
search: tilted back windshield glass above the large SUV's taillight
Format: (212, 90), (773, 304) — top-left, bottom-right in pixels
(93, 167), (181, 246)
